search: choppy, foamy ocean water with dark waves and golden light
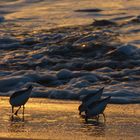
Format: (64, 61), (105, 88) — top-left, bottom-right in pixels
(0, 0), (140, 104)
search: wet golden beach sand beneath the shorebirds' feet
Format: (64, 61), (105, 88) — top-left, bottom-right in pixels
(0, 97), (140, 140)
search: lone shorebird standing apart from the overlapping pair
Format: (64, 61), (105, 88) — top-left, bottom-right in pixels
(9, 85), (33, 115)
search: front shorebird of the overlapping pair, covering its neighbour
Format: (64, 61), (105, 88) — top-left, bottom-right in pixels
(85, 96), (111, 121)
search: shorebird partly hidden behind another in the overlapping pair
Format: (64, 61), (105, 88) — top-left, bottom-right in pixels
(78, 87), (104, 115)
